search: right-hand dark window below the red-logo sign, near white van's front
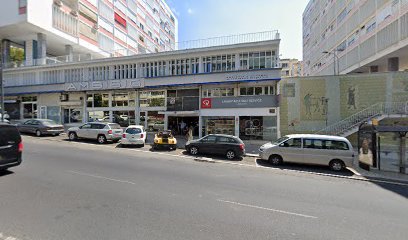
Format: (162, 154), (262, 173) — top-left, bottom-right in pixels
(239, 116), (277, 141)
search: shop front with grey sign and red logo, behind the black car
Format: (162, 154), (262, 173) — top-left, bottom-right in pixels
(200, 95), (279, 141)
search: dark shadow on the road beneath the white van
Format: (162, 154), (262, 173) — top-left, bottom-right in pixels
(256, 159), (354, 177)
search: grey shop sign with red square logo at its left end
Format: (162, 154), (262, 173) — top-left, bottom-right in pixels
(201, 95), (279, 109)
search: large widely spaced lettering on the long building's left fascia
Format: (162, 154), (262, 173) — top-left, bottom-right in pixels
(64, 79), (143, 91)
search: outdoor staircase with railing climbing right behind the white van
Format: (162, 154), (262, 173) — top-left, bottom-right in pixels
(316, 102), (408, 137)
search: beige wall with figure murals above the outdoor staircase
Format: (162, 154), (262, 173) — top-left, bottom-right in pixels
(280, 72), (408, 135)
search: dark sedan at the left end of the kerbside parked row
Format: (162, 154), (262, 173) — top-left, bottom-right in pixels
(17, 119), (64, 137)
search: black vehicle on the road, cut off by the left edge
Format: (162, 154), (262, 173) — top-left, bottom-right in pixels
(0, 123), (23, 170)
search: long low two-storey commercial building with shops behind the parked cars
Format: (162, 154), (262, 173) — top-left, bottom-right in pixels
(4, 39), (281, 140)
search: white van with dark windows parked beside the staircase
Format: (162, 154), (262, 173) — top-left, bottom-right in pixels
(259, 134), (354, 171)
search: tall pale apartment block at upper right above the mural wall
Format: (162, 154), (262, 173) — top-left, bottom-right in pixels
(303, 0), (408, 76)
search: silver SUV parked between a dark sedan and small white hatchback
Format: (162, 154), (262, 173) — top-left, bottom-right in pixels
(67, 122), (123, 144)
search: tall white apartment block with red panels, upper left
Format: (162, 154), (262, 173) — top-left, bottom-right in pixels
(0, 0), (178, 67)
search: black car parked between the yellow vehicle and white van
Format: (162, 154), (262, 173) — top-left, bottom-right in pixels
(186, 134), (245, 159)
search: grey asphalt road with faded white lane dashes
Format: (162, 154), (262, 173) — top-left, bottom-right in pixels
(0, 137), (408, 240)
